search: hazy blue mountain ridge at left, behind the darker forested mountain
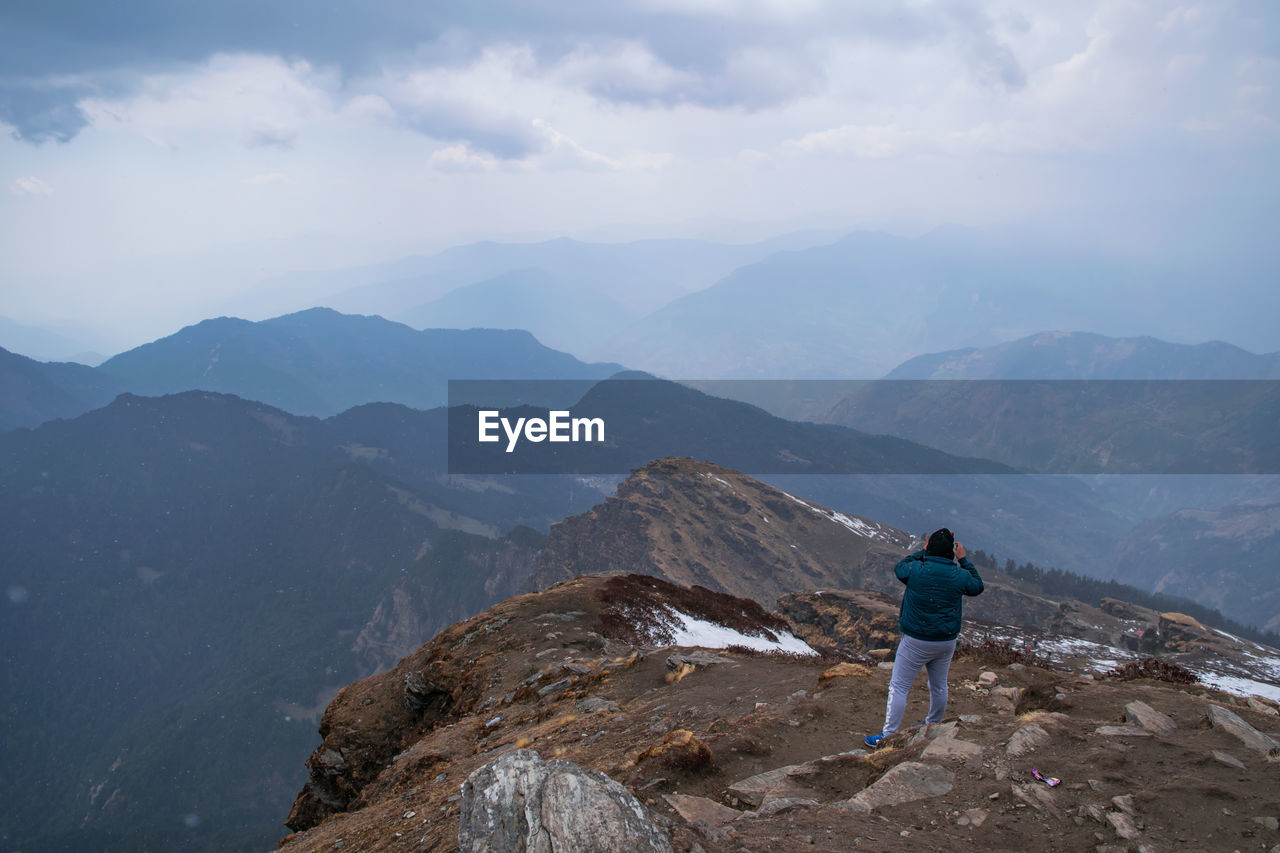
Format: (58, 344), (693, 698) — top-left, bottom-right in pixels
(0, 309), (621, 429)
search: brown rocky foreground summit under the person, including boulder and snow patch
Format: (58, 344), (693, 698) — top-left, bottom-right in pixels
(280, 575), (1280, 853)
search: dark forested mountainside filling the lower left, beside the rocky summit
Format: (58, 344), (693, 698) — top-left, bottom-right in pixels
(0, 392), (600, 849)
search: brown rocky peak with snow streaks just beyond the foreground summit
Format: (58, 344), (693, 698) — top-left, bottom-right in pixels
(534, 457), (911, 607)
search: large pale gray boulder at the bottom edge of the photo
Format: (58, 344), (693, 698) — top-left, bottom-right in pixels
(458, 749), (672, 853)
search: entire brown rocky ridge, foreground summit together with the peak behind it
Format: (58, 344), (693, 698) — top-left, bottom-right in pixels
(282, 459), (1280, 852)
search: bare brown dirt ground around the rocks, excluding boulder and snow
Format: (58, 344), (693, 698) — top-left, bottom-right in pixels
(280, 578), (1280, 853)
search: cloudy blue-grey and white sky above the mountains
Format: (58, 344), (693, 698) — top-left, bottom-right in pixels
(0, 0), (1280, 345)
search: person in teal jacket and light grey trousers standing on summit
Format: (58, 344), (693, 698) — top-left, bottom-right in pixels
(864, 528), (983, 749)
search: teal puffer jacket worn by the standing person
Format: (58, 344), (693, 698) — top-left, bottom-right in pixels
(893, 551), (983, 643)
